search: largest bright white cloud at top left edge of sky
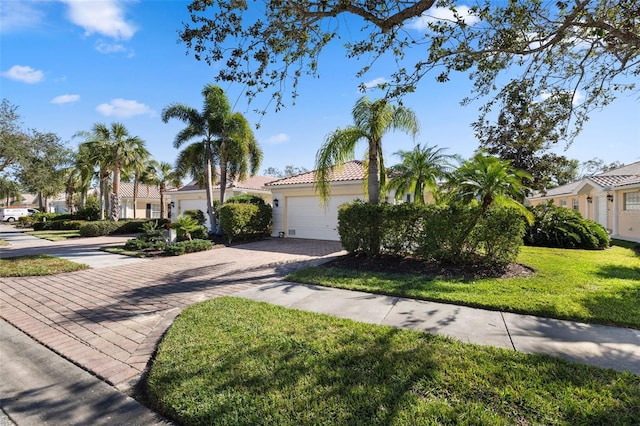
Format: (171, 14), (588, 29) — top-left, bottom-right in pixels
(61, 0), (137, 40)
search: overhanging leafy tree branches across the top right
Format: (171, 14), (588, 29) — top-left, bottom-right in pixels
(180, 0), (640, 139)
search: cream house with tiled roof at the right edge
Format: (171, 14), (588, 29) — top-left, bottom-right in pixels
(527, 161), (640, 242)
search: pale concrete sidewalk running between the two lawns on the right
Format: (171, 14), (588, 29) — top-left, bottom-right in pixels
(234, 282), (640, 374)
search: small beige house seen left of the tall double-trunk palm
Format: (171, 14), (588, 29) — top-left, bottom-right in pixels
(120, 182), (171, 219)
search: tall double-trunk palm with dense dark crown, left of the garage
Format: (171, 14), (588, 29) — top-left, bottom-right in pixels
(162, 84), (262, 230)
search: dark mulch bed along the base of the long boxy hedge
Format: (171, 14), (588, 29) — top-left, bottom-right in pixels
(322, 254), (534, 279)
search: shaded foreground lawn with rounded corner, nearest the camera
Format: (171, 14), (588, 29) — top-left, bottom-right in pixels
(147, 297), (640, 425)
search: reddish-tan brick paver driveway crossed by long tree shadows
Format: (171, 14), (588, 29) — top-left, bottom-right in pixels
(0, 239), (340, 389)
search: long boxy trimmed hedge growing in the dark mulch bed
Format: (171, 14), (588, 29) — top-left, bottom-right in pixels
(338, 201), (525, 266)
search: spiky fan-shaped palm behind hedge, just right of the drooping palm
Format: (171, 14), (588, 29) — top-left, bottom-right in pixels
(389, 144), (456, 204)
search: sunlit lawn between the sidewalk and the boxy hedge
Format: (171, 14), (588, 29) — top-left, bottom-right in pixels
(287, 246), (640, 329)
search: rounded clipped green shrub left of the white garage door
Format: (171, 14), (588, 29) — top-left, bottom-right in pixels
(219, 201), (272, 242)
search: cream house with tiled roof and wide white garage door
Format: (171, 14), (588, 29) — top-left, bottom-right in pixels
(266, 161), (366, 241)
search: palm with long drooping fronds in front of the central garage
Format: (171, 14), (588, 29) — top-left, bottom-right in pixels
(316, 96), (419, 204)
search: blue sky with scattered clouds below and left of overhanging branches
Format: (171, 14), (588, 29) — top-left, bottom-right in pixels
(0, 0), (640, 176)
